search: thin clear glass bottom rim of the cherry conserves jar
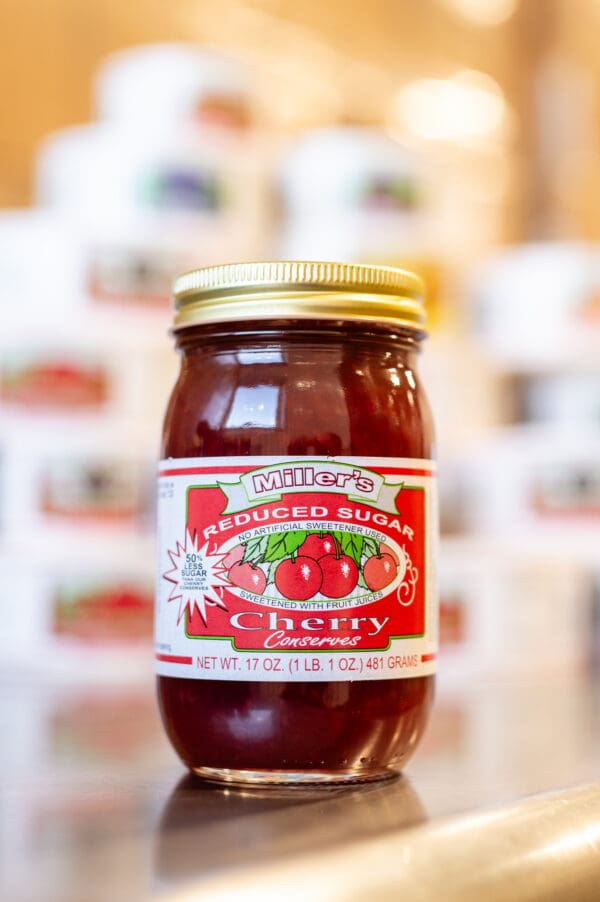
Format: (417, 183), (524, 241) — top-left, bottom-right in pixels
(190, 767), (400, 787)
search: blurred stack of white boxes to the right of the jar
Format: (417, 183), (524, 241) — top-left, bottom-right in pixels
(441, 243), (600, 677)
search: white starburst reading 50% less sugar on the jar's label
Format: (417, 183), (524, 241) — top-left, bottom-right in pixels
(163, 532), (229, 625)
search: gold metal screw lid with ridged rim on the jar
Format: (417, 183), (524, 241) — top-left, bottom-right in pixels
(173, 261), (425, 331)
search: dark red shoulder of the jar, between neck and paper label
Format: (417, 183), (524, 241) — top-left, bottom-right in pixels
(162, 344), (434, 457)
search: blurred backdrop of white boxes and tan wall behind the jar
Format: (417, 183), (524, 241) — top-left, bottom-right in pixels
(0, 0), (600, 736)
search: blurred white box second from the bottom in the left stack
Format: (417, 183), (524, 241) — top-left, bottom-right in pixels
(0, 415), (154, 536)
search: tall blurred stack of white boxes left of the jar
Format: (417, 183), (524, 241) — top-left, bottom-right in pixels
(0, 45), (266, 678)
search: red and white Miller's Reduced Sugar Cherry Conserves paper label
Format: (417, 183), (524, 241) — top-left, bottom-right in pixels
(155, 457), (438, 682)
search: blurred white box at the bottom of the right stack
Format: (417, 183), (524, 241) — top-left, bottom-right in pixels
(440, 538), (593, 685)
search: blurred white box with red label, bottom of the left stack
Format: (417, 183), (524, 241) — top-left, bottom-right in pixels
(0, 533), (153, 683)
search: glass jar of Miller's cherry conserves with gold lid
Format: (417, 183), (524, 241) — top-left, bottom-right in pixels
(156, 262), (437, 784)
